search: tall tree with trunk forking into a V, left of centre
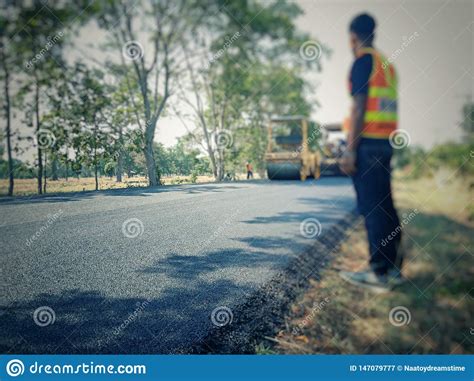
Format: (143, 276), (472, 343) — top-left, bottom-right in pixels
(98, 0), (217, 186)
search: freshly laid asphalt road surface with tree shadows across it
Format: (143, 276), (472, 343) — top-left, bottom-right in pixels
(0, 178), (355, 353)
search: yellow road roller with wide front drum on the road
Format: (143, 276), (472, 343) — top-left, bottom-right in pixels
(265, 116), (320, 181)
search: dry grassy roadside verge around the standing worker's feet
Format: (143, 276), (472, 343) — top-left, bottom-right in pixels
(257, 175), (474, 354)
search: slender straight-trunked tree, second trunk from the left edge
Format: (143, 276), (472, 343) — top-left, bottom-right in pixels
(14, 0), (91, 194)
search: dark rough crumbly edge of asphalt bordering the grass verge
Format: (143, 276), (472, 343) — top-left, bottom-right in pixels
(191, 211), (358, 354)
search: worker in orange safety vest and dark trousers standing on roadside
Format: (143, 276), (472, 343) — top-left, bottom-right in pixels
(340, 14), (402, 291)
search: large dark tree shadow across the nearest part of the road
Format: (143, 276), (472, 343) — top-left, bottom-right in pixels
(0, 274), (256, 354)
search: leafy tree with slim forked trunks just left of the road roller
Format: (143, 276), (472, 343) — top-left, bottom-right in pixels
(174, 0), (327, 181)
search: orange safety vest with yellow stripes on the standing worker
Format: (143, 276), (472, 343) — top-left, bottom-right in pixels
(352, 48), (397, 139)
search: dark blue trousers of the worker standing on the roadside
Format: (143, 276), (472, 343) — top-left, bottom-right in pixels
(353, 138), (401, 274)
